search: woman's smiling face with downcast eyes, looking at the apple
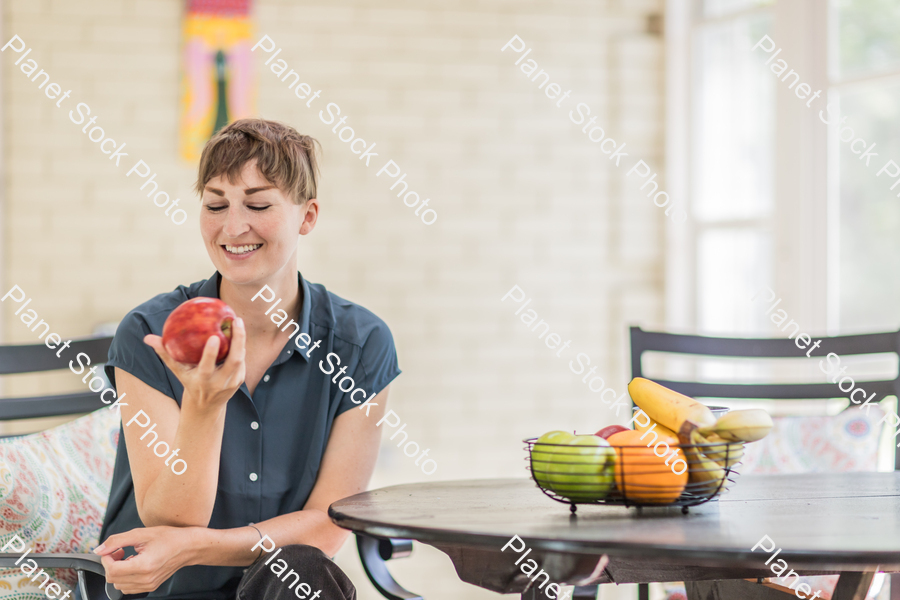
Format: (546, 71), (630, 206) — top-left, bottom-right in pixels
(200, 160), (319, 288)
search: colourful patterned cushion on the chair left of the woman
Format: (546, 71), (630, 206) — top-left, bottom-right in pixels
(0, 408), (120, 600)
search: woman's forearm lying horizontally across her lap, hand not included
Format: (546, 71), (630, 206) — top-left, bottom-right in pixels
(190, 509), (349, 567)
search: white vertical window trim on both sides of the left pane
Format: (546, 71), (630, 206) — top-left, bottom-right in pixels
(666, 0), (838, 333)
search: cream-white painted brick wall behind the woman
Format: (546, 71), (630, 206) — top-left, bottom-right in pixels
(0, 0), (664, 599)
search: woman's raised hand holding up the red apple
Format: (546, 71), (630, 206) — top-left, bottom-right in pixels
(144, 319), (247, 412)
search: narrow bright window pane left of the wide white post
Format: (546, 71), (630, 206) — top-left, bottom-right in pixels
(689, 0), (775, 334)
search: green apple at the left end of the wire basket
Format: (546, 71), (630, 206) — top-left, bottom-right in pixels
(532, 432), (616, 502)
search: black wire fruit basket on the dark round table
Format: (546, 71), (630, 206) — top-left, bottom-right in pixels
(523, 438), (744, 513)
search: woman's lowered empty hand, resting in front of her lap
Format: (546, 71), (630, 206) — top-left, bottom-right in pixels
(94, 527), (197, 594)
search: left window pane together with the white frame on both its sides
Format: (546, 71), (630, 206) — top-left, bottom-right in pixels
(666, 0), (839, 336)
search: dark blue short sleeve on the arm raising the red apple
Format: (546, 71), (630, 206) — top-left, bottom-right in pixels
(105, 311), (177, 399)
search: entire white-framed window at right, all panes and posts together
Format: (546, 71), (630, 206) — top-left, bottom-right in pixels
(667, 0), (900, 335)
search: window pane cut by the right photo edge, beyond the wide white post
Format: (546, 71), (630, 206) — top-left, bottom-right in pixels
(829, 0), (900, 332)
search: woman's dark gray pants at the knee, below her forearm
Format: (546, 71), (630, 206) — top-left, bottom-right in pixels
(237, 544), (356, 600)
